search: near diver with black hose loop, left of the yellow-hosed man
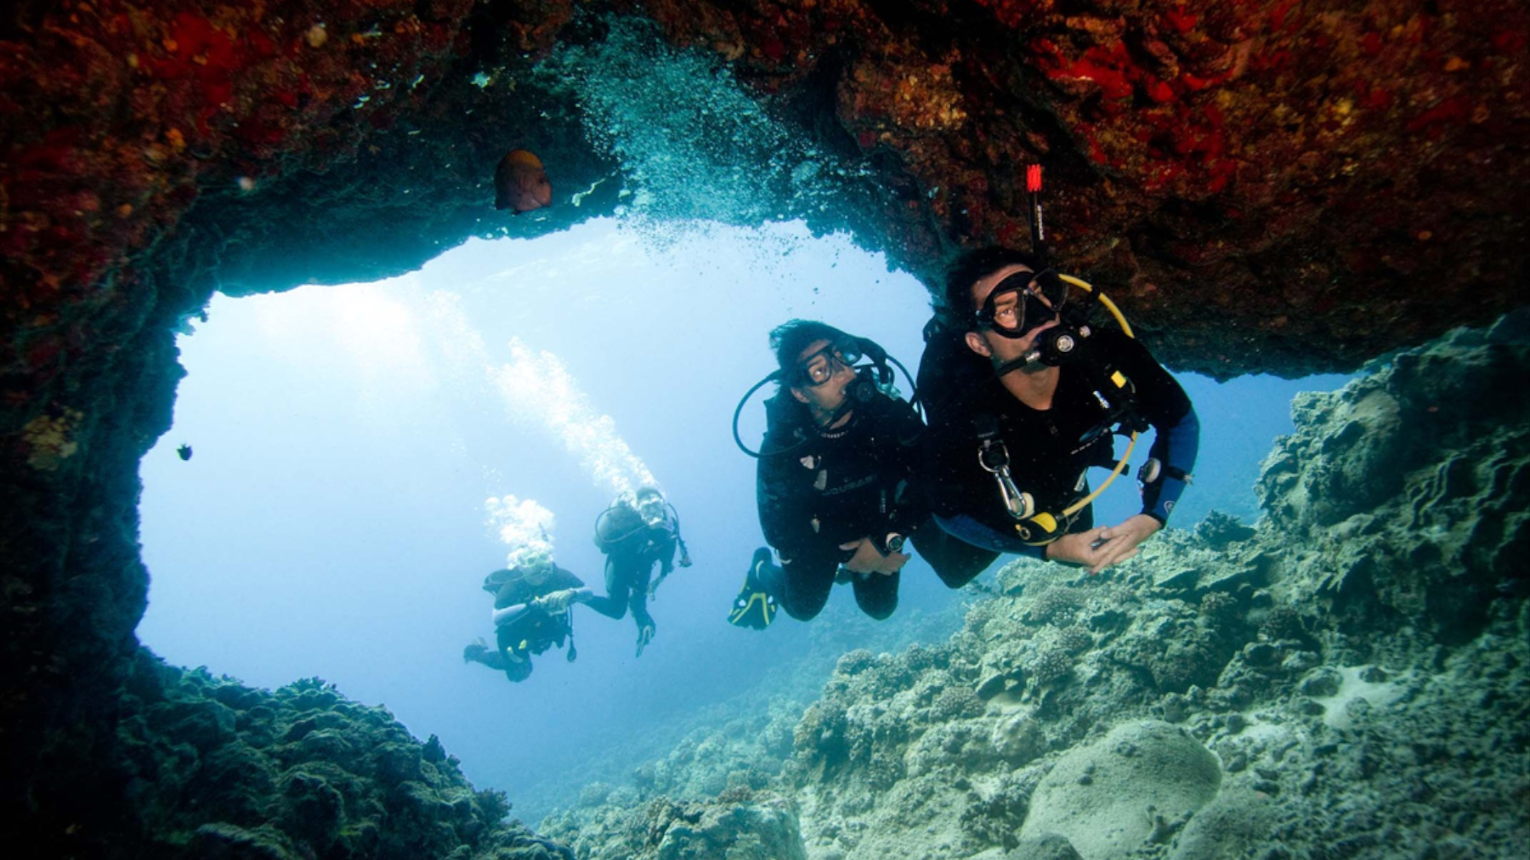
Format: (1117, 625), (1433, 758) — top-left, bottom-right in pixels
(728, 320), (991, 629)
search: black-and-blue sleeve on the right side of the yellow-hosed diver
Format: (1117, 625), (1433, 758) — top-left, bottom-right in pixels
(1117, 335), (1201, 523)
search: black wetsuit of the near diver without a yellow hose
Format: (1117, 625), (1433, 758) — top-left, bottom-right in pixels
(756, 392), (991, 621)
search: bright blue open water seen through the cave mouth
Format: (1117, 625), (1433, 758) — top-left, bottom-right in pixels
(139, 214), (1343, 822)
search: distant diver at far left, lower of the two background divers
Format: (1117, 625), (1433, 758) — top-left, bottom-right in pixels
(462, 551), (594, 682)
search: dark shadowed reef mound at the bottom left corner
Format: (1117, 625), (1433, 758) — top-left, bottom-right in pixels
(43, 650), (571, 860)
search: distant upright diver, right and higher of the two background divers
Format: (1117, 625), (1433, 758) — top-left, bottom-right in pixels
(586, 487), (692, 656)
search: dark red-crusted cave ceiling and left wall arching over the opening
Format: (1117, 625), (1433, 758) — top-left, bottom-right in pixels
(0, 0), (1530, 850)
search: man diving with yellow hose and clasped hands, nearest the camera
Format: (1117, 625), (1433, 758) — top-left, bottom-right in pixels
(920, 248), (1200, 572)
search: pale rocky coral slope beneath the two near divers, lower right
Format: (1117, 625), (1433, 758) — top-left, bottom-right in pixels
(546, 317), (1530, 860)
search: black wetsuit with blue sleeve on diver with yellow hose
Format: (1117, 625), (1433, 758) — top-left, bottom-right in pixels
(920, 329), (1200, 557)
